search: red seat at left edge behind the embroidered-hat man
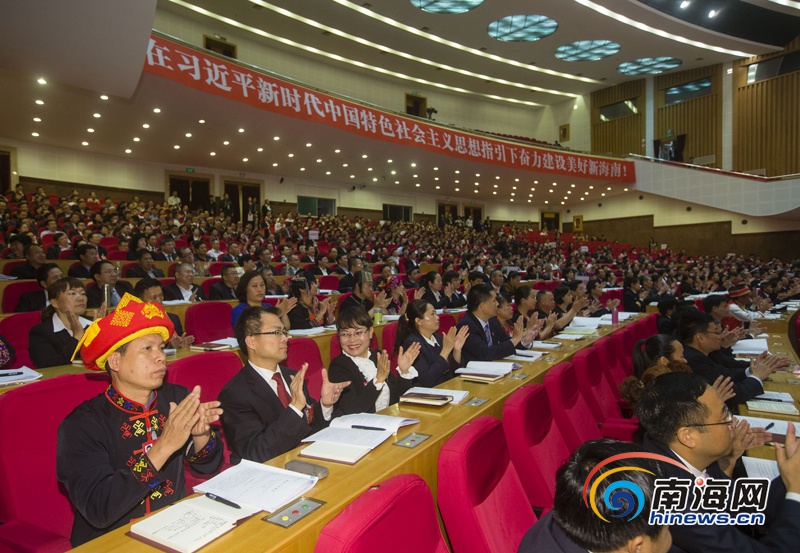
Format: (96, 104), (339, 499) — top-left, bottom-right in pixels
(0, 373), (108, 553)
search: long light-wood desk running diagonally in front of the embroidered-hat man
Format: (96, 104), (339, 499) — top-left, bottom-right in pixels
(76, 323), (627, 553)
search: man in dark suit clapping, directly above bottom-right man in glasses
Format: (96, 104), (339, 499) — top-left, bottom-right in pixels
(677, 311), (783, 403)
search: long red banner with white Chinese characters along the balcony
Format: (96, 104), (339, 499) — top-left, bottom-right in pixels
(144, 34), (636, 182)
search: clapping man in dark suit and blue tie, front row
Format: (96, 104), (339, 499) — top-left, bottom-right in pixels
(457, 284), (533, 365)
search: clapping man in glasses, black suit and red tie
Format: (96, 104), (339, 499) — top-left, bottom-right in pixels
(219, 306), (349, 464)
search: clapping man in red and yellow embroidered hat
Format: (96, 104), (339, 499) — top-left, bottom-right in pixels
(56, 294), (222, 546)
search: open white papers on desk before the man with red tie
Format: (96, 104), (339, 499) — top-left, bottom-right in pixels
(194, 459), (317, 513)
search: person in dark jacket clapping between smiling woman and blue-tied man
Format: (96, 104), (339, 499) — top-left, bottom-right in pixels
(393, 299), (469, 388)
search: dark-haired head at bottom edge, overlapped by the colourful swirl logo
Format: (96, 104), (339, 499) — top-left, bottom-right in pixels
(519, 439), (672, 553)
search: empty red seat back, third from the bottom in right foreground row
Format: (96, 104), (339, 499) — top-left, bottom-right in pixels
(503, 384), (570, 511)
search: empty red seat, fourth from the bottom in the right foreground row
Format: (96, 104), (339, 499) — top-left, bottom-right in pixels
(544, 362), (635, 452)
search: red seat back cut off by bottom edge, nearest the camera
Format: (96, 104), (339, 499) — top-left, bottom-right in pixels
(314, 474), (449, 553)
